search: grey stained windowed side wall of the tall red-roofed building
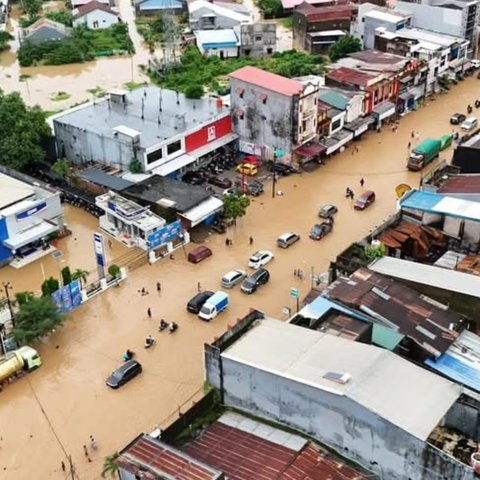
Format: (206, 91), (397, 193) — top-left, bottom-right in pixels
(230, 78), (298, 153)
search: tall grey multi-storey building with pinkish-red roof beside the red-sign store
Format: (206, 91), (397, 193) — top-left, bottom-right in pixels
(230, 67), (318, 159)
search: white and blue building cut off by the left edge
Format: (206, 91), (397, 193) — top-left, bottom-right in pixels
(0, 173), (65, 268)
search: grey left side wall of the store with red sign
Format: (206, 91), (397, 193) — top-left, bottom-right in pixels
(53, 120), (143, 169)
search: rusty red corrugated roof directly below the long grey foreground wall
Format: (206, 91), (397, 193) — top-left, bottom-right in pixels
(184, 422), (367, 480)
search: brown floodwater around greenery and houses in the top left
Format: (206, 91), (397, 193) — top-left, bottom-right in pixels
(0, 0), (150, 111)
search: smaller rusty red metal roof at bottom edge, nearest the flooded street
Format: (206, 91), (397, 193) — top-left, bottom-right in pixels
(117, 436), (221, 480)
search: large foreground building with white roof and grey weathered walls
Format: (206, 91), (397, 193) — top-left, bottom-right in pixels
(204, 316), (480, 480)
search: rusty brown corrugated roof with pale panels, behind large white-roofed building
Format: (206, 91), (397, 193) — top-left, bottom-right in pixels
(327, 268), (463, 357)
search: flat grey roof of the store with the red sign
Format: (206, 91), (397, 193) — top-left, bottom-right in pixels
(53, 86), (228, 148)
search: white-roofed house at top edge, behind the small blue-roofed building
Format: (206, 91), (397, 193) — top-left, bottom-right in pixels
(188, 0), (253, 30)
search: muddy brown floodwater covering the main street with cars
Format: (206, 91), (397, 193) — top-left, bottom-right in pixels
(0, 79), (480, 480)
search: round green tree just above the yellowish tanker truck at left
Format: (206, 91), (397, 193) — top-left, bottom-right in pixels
(12, 297), (63, 342)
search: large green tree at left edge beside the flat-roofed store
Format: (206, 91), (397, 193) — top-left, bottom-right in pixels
(0, 89), (50, 171)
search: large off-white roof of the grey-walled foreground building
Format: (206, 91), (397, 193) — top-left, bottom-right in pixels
(222, 319), (462, 441)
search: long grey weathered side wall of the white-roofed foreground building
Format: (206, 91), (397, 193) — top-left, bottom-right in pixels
(214, 360), (473, 480)
